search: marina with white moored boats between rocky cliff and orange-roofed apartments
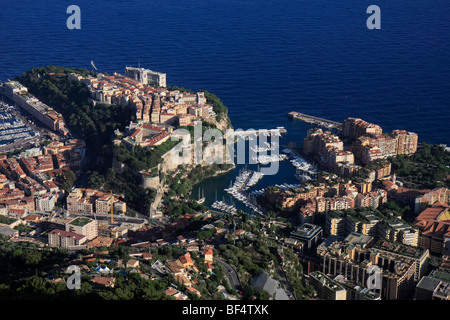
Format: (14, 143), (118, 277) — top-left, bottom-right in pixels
(193, 121), (318, 216)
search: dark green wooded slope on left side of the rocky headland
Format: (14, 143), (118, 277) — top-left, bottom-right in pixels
(18, 66), (134, 171)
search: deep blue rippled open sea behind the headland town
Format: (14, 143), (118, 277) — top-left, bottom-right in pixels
(0, 0), (450, 208)
